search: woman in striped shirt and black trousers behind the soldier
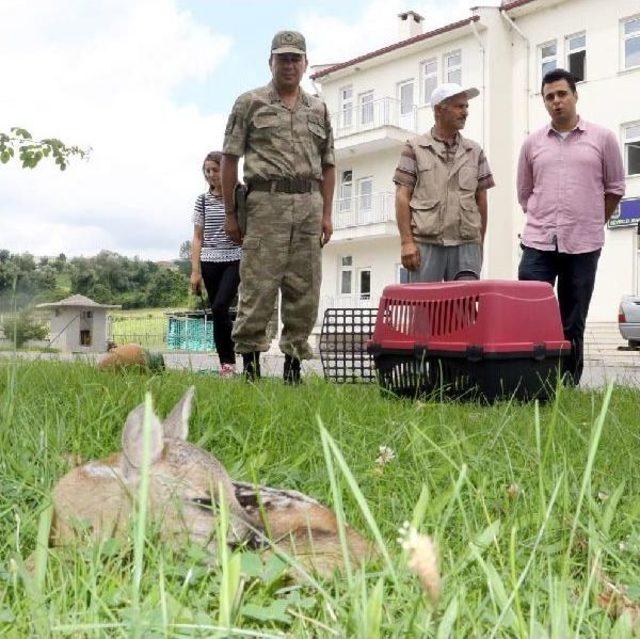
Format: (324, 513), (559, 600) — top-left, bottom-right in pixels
(191, 151), (242, 377)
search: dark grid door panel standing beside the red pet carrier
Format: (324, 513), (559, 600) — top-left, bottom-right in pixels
(319, 308), (378, 383)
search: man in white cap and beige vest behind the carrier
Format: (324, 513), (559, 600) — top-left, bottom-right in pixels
(393, 83), (494, 282)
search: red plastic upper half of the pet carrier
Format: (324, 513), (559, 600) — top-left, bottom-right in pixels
(370, 280), (571, 354)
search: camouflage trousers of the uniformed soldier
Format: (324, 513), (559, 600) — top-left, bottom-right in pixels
(232, 191), (322, 359)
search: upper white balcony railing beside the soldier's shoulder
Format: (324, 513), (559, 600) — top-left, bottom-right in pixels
(331, 98), (417, 138)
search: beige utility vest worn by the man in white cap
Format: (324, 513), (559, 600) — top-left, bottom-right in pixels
(409, 133), (481, 246)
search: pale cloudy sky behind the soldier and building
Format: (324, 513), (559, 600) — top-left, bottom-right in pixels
(0, 0), (499, 260)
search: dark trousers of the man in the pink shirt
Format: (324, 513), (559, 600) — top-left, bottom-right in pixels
(518, 246), (601, 386)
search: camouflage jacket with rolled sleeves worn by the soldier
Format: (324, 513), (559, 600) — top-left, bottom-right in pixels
(223, 82), (335, 180)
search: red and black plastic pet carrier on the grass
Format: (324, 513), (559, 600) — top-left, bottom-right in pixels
(368, 280), (571, 401)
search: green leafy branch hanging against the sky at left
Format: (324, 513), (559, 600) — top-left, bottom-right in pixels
(0, 127), (91, 171)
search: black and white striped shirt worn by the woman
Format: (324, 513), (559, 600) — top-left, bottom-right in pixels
(193, 191), (242, 262)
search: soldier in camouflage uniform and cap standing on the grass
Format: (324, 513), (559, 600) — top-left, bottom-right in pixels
(222, 31), (335, 383)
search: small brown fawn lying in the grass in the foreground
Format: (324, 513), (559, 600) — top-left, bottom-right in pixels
(51, 387), (369, 575)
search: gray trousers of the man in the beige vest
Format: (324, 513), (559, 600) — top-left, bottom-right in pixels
(409, 242), (482, 282)
